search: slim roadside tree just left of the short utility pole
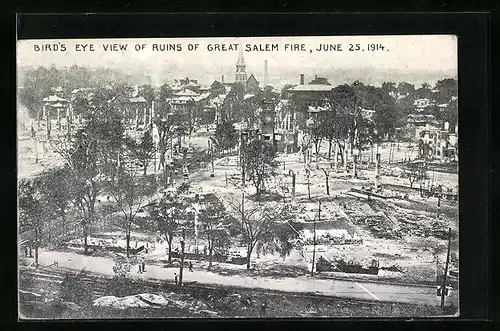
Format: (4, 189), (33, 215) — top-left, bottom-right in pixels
(148, 195), (185, 262)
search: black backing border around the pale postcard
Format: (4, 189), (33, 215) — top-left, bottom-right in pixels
(3, 11), (492, 329)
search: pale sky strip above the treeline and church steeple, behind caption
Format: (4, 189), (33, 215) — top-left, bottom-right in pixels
(17, 35), (458, 85)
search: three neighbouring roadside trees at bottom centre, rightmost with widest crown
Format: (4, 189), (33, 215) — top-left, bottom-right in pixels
(148, 189), (302, 269)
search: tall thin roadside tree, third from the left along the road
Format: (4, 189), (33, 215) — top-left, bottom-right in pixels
(107, 169), (154, 257)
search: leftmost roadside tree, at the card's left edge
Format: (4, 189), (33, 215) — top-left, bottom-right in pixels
(18, 179), (47, 266)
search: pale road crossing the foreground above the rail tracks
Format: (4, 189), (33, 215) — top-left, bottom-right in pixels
(35, 250), (439, 305)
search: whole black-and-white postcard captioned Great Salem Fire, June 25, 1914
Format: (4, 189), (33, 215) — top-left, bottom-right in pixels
(17, 35), (458, 320)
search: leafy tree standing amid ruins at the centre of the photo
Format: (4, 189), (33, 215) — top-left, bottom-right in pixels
(244, 139), (279, 200)
